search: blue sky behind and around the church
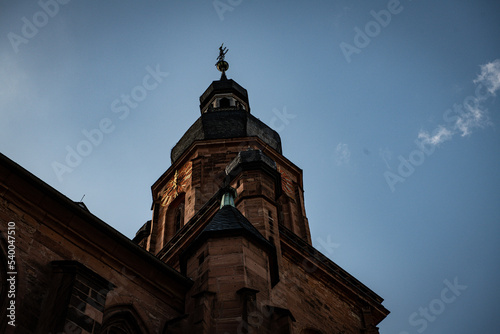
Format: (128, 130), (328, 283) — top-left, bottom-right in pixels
(0, 0), (500, 334)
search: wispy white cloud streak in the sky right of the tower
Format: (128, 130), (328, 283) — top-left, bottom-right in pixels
(418, 59), (500, 146)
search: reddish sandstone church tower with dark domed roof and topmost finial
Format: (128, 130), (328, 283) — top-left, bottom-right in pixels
(134, 46), (389, 334)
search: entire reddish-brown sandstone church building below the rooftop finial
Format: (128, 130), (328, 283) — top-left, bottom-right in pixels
(0, 77), (389, 334)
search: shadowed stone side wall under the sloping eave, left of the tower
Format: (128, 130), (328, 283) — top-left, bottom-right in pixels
(0, 159), (188, 334)
